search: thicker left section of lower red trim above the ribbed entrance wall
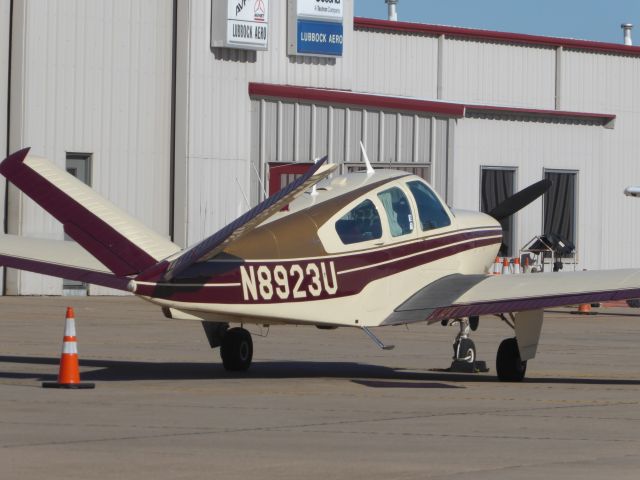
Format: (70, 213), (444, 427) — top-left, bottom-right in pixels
(249, 83), (464, 117)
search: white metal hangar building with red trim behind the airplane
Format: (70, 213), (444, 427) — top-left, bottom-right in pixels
(0, 0), (640, 295)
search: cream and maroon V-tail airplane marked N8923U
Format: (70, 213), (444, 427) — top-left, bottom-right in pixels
(0, 149), (640, 381)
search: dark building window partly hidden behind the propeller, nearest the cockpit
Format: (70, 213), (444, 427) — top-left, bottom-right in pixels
(480, 168), (516, 257)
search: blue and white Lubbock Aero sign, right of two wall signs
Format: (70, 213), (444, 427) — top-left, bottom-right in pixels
(287, 0), (344, 57)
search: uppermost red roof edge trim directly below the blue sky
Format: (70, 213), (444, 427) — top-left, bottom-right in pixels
(353, 17), (640, 56)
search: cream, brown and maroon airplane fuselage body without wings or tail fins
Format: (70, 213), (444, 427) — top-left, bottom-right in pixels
(135, 172), (502, 326)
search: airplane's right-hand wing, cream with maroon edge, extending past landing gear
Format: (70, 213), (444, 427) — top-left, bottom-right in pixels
(382, 269), (640, 325)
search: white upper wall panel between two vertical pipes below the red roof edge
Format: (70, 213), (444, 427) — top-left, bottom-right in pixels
(442, 39), (556, 109)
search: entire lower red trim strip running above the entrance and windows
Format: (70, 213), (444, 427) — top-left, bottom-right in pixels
(249, 83), (616, 124)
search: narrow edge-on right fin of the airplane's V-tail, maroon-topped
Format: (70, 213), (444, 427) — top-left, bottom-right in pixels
(164, 157), (337, 280)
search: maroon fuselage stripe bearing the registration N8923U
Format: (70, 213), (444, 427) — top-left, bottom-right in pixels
(136, 229), (501, 304)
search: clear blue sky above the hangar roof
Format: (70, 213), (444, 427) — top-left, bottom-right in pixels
(354, 0), (640, 45)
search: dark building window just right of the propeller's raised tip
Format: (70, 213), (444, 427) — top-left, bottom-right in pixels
(543, 170), (578, 249)
